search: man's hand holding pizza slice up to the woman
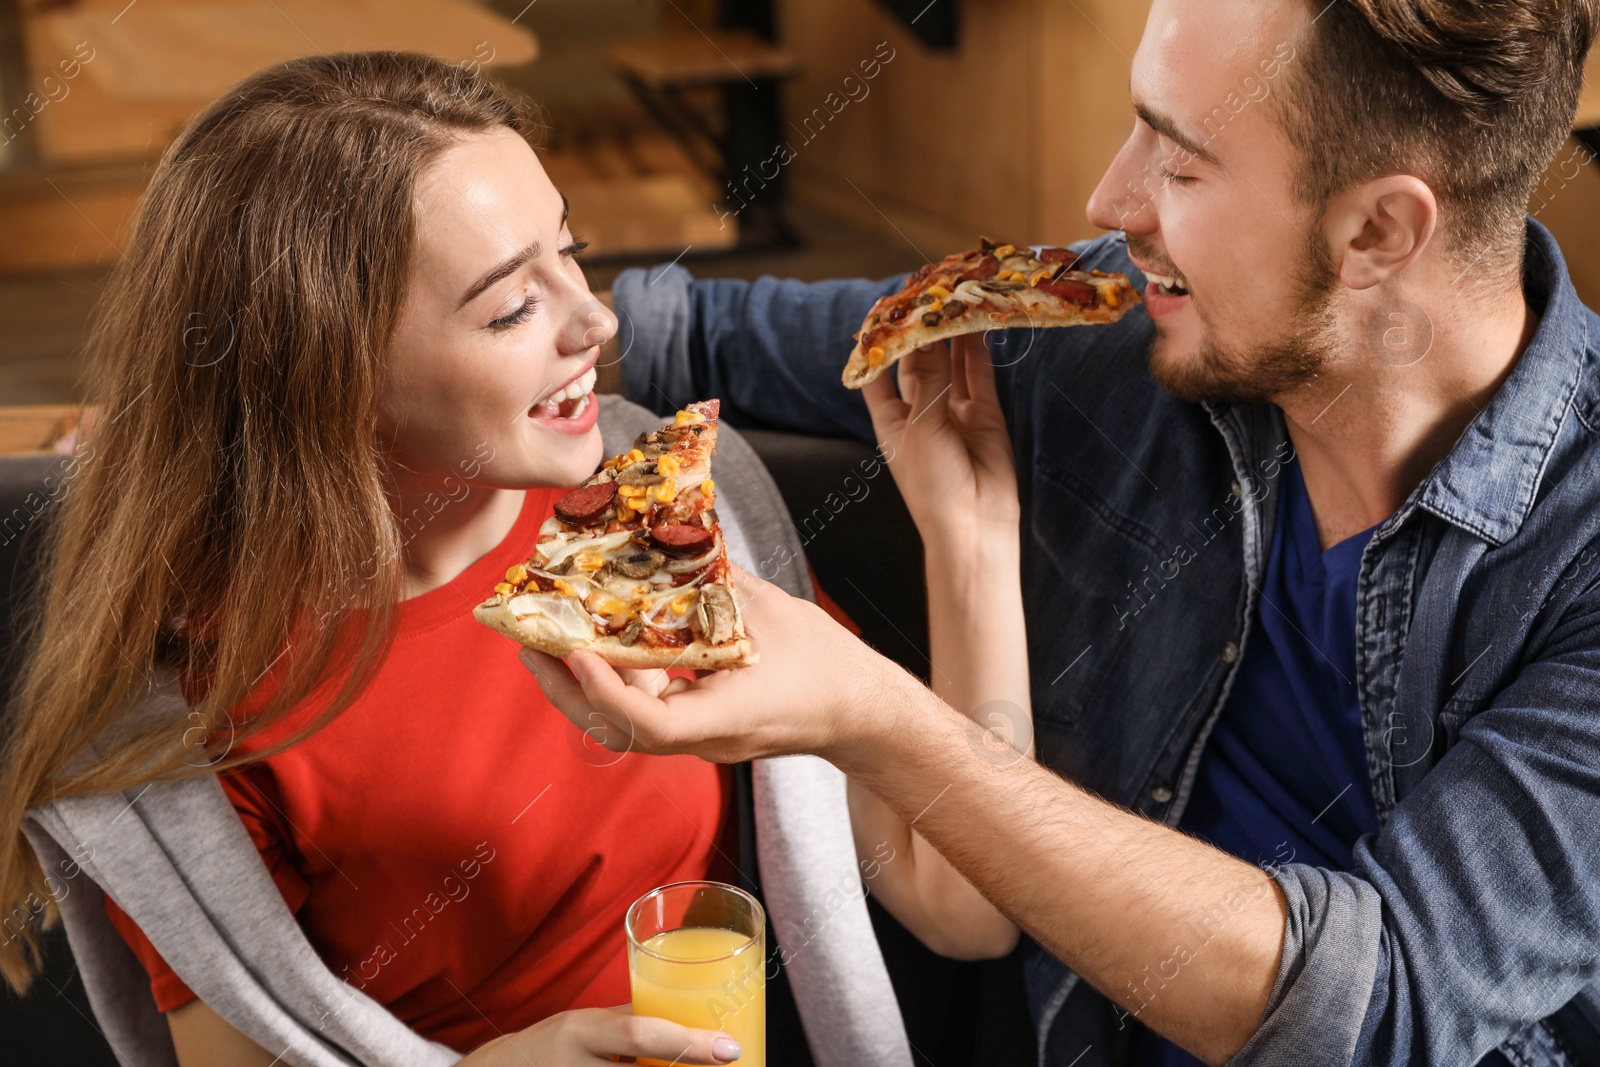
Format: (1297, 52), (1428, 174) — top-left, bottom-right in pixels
(522, 568), (928, 763)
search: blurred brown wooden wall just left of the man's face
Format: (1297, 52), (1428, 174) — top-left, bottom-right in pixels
(781, 0), (1149, 254)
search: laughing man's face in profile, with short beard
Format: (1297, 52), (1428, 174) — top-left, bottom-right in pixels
(1088, 0), (1338, 402)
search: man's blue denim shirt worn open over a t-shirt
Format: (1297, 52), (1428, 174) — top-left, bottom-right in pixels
(614, 219), (1600, 1067)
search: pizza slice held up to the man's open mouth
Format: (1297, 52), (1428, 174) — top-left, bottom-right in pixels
(843, 237), (1141, 389)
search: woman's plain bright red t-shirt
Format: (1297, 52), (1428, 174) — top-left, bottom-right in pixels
(106, 490), (736, 1051)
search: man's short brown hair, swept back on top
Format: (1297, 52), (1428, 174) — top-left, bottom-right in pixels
(1282, 0), (1600, 278)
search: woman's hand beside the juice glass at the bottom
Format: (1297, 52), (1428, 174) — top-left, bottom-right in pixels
(461, 1005), (741, 1067)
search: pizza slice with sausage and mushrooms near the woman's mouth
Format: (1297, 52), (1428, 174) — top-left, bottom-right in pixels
(472, 400), (755, 670)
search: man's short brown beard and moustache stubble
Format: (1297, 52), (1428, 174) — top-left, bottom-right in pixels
(1128, 230), (1339, 403)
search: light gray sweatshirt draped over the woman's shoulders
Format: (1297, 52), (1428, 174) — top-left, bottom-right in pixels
(22, 397), (912, 1067)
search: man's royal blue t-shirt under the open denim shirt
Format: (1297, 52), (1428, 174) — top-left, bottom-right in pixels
(1136, 462), (1378, 1067)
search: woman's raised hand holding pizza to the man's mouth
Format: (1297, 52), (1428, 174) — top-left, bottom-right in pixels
(861, 334), (1021, 550)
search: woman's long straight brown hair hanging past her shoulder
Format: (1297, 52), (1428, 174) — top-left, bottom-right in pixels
(0, 53), (533, 990)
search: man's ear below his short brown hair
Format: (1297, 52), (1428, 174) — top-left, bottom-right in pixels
(1322, 174), (1438, 290)
